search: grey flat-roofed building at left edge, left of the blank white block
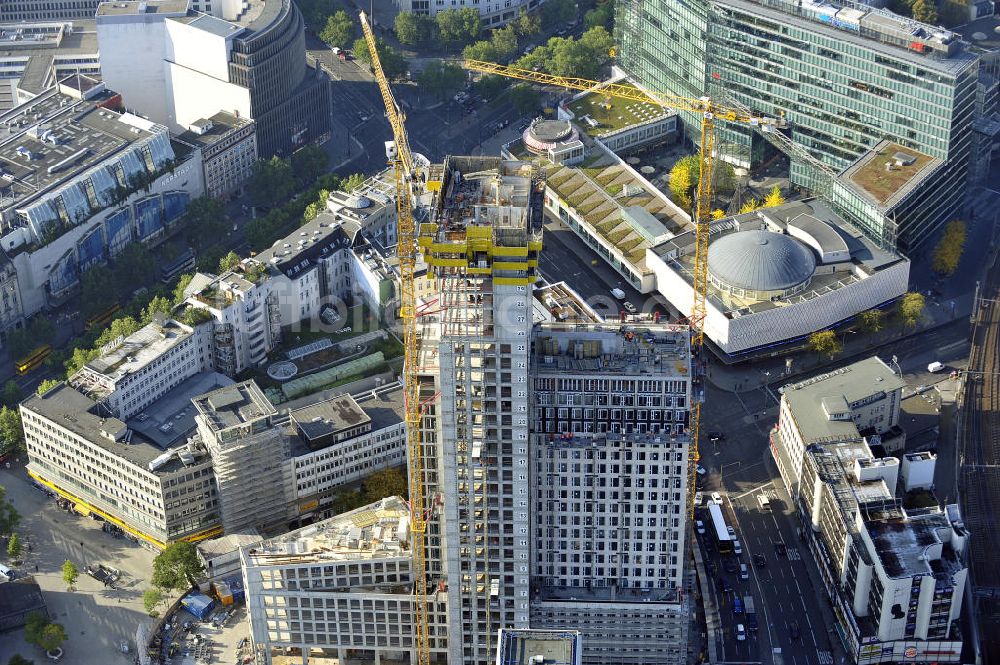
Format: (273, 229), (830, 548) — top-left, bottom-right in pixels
(0, 20), (101, 110)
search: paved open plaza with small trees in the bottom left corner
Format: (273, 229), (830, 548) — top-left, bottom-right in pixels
(0, 466), (162, 665)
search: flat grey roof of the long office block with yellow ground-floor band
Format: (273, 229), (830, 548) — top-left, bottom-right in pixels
(23, 372), (230, 475)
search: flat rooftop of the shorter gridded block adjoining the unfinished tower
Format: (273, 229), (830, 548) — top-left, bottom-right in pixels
(532, 323), (691, 376)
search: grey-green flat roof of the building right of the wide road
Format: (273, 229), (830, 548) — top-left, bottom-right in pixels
(781, 356), (906, 445)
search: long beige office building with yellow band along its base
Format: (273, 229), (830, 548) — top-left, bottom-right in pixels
(21, 366), (229, 548)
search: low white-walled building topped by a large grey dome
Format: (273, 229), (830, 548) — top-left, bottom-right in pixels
(646, 199), (910, 362)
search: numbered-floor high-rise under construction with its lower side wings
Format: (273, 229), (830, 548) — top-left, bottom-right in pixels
(243, 157), (693, 665)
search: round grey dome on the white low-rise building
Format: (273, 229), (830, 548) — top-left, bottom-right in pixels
(708, 229), (816, 300)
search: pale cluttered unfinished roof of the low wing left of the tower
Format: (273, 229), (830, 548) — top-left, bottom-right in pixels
(247, 496), (410, 566)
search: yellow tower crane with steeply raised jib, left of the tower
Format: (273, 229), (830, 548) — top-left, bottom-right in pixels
(361, 12), (431, 665)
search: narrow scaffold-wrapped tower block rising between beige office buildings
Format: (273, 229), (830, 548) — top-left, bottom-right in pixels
(192, 381), (290, 533)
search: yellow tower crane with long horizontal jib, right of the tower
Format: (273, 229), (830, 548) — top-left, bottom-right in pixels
(464, 60), (781, 516)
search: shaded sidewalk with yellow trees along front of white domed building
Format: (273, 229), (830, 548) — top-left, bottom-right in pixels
(708, 293), (973, 392)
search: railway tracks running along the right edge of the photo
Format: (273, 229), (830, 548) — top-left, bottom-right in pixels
(959, 253), (1000, 663)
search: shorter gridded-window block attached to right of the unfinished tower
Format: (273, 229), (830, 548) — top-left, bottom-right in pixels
(531, 324), (692, 664)
